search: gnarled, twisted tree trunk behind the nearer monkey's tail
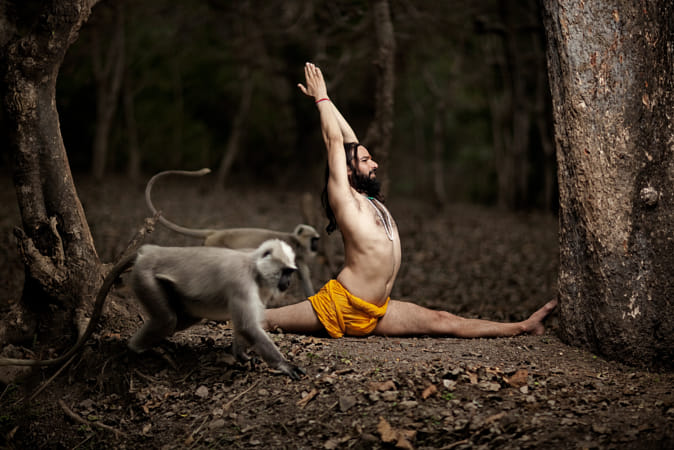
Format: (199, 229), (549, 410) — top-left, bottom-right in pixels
(0, 0), (101, 345)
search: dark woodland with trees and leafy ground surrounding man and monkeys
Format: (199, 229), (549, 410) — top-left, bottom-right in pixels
(0, 0), (674, 449)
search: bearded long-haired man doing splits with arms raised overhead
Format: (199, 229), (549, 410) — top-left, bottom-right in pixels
(265, 63), (557, 338)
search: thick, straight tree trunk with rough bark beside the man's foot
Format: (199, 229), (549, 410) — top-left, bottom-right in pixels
(544, 0), (674, 368)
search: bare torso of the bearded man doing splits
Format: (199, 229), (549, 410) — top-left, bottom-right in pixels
(337, 191), (401, 306)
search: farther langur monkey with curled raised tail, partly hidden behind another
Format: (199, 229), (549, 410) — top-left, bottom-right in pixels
(145, 168), (320, 297)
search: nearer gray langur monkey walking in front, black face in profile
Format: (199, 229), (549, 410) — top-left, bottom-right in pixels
(0, 239), (305, 380)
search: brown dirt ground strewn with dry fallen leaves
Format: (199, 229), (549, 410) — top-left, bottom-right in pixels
(0, 174), (674, 449)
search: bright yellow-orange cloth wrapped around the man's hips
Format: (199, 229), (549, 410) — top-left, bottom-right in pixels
(309, 280), (391, 338)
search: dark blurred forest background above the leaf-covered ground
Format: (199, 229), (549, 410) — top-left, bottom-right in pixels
(2, 0), (557, 211)
